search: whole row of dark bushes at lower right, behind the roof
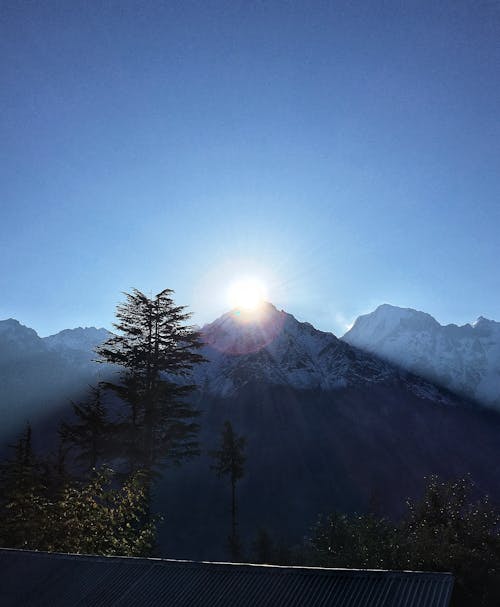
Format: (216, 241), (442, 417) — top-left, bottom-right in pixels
(302, 476), (500, 607)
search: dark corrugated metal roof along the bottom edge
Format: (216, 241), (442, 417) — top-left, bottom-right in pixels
(0, 548), (453, 607)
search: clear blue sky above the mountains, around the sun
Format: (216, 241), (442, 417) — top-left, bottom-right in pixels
(0, 0), (500, 335)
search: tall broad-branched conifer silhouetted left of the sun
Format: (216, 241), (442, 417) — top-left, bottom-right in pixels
(96, 289), (203, 473)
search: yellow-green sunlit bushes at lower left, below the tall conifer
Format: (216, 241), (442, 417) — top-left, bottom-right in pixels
(0, 427), (156, 556)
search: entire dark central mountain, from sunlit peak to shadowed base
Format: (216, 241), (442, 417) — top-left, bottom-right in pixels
(158, 305), (500, 558)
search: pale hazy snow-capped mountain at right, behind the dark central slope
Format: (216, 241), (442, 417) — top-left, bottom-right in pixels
(342, 304), (500, 407)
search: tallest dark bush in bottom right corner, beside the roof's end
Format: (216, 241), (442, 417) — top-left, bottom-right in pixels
(398, 476), (500, 606)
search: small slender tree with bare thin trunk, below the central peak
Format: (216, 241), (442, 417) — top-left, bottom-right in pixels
(210, 421), (246, 560)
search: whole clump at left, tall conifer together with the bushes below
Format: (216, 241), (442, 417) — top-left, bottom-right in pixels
(0, 289), (202, 555)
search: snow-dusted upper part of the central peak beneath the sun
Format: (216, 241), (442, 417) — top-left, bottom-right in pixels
(194, 303), (454, 402)
